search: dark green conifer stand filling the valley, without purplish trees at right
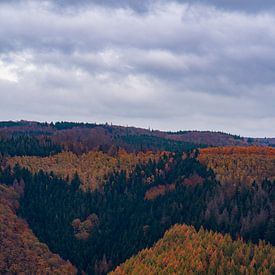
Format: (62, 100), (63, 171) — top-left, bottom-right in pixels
(2, 155), (218, 274)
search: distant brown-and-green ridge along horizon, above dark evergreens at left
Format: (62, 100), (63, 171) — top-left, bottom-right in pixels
(0, 120), (275, 153)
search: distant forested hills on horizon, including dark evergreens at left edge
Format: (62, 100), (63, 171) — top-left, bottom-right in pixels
(0, 121), (275, 156)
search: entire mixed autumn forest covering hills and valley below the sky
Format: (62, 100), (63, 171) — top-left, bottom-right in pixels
(0, 122), (275, 274)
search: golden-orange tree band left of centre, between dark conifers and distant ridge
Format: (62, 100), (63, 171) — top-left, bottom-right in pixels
(8, 149), (163, 190)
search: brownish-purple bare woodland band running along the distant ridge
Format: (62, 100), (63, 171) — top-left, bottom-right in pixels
(0, 121), (266, 153)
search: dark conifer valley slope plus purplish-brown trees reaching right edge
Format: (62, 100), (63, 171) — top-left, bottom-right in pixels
(0, 153), (275, 274)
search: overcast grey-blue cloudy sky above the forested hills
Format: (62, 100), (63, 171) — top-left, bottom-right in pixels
(0, 0), (275, 137)
